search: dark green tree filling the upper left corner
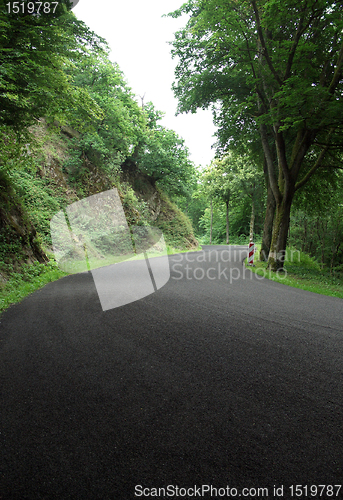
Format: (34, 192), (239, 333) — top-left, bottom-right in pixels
(0, 0), (106, 130)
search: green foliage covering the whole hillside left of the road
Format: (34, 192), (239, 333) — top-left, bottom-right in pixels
(0, 0), (202, 309)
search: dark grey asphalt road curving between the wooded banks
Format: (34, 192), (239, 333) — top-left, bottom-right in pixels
(0, 246), (343, 500)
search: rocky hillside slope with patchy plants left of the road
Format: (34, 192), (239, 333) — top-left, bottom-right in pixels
(0, 120), (197, 282)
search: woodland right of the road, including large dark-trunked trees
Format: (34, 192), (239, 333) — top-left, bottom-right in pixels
(169, 0), (343, 271)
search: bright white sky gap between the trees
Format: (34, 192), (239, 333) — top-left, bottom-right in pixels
(73, 0), (215, 167)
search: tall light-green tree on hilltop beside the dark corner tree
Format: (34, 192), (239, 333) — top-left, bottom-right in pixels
(63, 52), (145, 179)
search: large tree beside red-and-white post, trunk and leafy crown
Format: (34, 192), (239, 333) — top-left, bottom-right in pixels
(170, 0), (343, 270)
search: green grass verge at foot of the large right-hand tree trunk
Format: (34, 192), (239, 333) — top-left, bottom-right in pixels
(245, 245), (343, 299)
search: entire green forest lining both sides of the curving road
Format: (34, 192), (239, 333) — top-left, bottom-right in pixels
(0, 0), (343, 308)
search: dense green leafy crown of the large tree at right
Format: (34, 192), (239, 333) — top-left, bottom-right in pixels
(170, 0), (342, 136)
